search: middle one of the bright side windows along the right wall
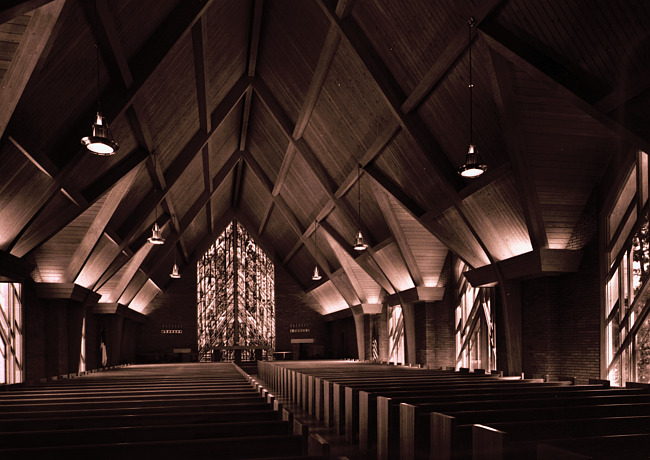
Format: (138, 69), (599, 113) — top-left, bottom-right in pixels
(454, 260), (496, 370)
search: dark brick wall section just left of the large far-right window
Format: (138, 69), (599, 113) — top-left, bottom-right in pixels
(522, 197), (600, 383)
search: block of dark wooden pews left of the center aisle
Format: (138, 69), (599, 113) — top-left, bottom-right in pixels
(0, 363), (329, 460)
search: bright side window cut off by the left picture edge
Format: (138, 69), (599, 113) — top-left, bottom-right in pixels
(0, 283), (24, 384)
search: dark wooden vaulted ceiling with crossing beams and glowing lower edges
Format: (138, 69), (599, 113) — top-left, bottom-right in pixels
(0, 0), (650, 313)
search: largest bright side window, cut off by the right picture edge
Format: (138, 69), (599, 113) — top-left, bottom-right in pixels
(603, 152), (650, 386)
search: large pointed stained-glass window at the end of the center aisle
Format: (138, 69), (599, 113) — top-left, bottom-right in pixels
(197, 221), (275, 361)
